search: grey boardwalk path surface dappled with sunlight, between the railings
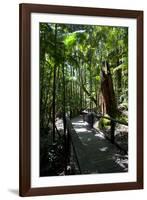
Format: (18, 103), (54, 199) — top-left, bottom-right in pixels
(72, 116), (128, 174)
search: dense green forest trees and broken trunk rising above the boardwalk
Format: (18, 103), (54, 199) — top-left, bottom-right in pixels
(40, 23), (128, 128)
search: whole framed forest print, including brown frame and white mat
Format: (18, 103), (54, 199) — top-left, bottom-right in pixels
(20, 4), (143, 196)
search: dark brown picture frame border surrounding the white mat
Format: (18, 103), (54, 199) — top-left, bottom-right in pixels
(19, 4), (143, 196)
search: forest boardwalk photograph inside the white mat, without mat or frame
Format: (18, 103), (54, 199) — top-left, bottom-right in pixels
(39, 23), (128, 177)
